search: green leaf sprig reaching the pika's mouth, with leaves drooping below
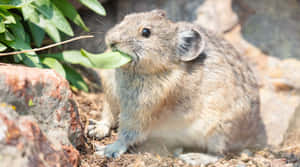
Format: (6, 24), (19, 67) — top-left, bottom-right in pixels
(41, 49), (131, 91)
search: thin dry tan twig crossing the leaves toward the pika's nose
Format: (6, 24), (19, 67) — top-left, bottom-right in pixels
(0, 35), (94, 56)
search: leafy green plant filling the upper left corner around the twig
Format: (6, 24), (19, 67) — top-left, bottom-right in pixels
(0, 0), (106, 91)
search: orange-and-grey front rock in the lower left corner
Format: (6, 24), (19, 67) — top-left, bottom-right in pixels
(0, 103), (79, 167)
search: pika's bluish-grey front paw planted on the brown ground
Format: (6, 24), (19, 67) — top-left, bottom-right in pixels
(104, 141), (127, 158)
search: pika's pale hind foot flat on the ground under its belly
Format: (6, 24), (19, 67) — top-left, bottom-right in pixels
(178, 153), (221, 166)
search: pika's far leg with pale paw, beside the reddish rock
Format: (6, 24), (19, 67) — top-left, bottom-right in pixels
(87, 98), (118, 140)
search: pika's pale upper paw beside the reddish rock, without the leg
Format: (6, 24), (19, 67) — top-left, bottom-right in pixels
(87, 119), (110, 140)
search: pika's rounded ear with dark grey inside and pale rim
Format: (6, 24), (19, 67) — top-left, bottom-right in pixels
(176, 28), (205, 61)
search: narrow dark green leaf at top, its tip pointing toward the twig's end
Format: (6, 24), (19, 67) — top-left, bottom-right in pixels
(52, 0), (89, 31)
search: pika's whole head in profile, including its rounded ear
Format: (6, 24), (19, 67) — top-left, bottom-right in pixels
(106, 10), (204, 74)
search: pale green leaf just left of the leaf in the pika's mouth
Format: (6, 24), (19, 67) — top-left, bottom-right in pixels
(41, 50), (93, 67)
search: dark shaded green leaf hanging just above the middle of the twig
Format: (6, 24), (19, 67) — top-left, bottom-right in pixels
(28, 22), (45, 47)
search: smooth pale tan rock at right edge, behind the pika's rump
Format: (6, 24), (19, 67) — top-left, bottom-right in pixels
(260, 88), (300, 146)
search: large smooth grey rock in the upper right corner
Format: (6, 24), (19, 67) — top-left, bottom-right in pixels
(233, 0), (300, 58)
